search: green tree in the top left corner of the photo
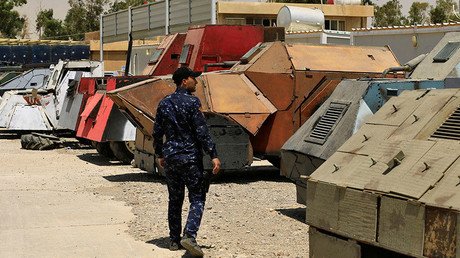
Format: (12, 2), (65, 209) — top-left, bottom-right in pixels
(0, 0), (27, 38)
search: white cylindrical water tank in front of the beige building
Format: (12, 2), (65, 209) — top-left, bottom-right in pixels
(276, 5), (324, 32)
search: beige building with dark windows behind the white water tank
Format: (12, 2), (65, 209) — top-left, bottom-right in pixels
(217, 1), (374, 31)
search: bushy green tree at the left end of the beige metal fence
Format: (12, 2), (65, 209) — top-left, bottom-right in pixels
(64, 0), (109, 40)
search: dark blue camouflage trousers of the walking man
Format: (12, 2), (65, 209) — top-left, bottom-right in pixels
(165, 161), (206, 242)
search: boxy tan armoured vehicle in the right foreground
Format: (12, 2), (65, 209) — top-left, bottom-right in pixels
(305, 89), (460, 258)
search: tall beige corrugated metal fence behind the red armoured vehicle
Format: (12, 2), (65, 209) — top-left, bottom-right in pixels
(101, 0), (216, 42)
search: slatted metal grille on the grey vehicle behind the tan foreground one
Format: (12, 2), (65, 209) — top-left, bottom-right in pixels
(306, 102), (349, 145)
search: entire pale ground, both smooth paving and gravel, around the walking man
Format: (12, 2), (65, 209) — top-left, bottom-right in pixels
(0, 139), (308, 257)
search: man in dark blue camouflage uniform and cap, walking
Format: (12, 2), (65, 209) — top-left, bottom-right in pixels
(153, 67), (221, 256)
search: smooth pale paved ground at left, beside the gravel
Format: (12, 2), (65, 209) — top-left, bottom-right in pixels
(0, 140), (174, 257)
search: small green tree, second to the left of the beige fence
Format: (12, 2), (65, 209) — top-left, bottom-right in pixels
(35, 9), (66, 39)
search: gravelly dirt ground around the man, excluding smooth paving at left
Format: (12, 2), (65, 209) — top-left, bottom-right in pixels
(1, 136), (308, 257)
